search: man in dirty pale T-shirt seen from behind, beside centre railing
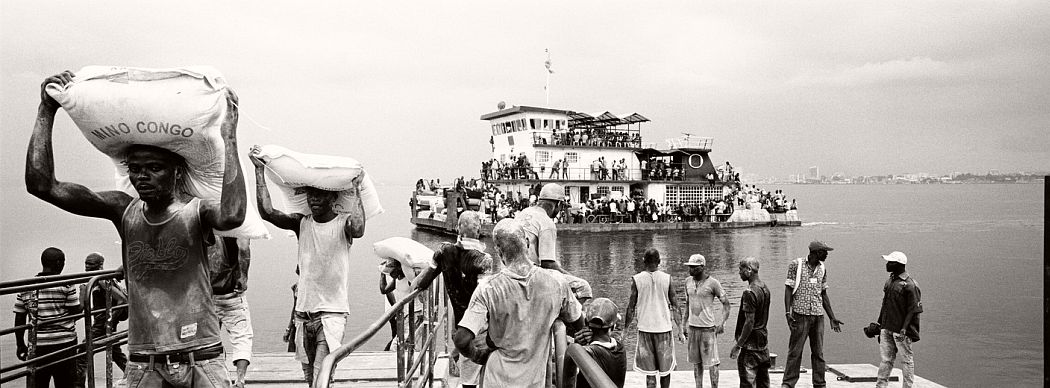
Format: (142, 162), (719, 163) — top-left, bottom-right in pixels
(455, 219), (584, 387)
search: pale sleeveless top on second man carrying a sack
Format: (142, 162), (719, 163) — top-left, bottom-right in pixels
(295, 214), (351, 312)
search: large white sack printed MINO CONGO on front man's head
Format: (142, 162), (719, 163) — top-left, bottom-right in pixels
(45, 66), (269, 238)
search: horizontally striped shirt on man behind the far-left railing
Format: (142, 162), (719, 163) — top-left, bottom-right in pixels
(15, 285), (80, 345)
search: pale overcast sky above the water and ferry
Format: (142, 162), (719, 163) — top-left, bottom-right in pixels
(0, 1), (1050, 189)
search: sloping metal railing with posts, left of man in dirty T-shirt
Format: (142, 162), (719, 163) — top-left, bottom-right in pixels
(314, 277), (452, 388)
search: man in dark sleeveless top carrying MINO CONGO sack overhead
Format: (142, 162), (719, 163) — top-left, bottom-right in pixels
(25, 71), (247, 387)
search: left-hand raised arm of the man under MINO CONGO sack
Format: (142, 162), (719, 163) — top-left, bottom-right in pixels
(25, 70), (132, 224)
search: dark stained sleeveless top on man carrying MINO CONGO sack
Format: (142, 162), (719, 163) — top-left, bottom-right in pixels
(121, 198), (221, 353)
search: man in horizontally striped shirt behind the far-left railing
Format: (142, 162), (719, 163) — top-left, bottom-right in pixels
(15, 247), (84, 387)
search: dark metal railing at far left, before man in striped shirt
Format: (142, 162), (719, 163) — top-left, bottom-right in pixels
(0, 270), (127, 388)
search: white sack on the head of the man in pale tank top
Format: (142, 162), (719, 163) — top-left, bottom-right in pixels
(258, 146), (383, 219)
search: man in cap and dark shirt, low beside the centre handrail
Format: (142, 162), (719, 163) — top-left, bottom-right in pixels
(565, 298), (627, 388)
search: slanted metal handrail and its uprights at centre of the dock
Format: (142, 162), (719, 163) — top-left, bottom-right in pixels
(313, 277), (448, 388)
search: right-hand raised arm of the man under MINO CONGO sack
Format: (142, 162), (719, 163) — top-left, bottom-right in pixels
(201, 88), (248, 231)
